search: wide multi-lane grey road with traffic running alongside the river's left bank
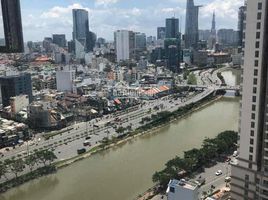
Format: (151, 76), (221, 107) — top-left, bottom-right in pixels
(0, 87), (214, 161)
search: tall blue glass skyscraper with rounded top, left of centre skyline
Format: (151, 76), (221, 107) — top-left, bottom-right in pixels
(73, 9), (89, 58)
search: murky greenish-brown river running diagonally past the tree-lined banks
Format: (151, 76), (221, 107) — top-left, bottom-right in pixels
(0, 70), (239, 200)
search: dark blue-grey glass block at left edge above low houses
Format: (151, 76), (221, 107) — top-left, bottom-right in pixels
(0, 73), (33, 107)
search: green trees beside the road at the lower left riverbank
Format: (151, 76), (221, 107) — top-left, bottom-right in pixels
(0, 150), (57, 180)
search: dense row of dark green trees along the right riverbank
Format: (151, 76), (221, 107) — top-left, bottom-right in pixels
(152, 131), (238, 189)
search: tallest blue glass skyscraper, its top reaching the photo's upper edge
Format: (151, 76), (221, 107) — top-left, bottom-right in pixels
(184, 0), (200, 49)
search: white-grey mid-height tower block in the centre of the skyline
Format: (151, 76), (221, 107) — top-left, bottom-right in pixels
(114, 30), (135, 62)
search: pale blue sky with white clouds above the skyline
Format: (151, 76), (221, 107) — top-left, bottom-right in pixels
(0, 0), (244, 41)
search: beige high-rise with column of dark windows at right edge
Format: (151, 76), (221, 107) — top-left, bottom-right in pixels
(231, 0), (268, 200)
